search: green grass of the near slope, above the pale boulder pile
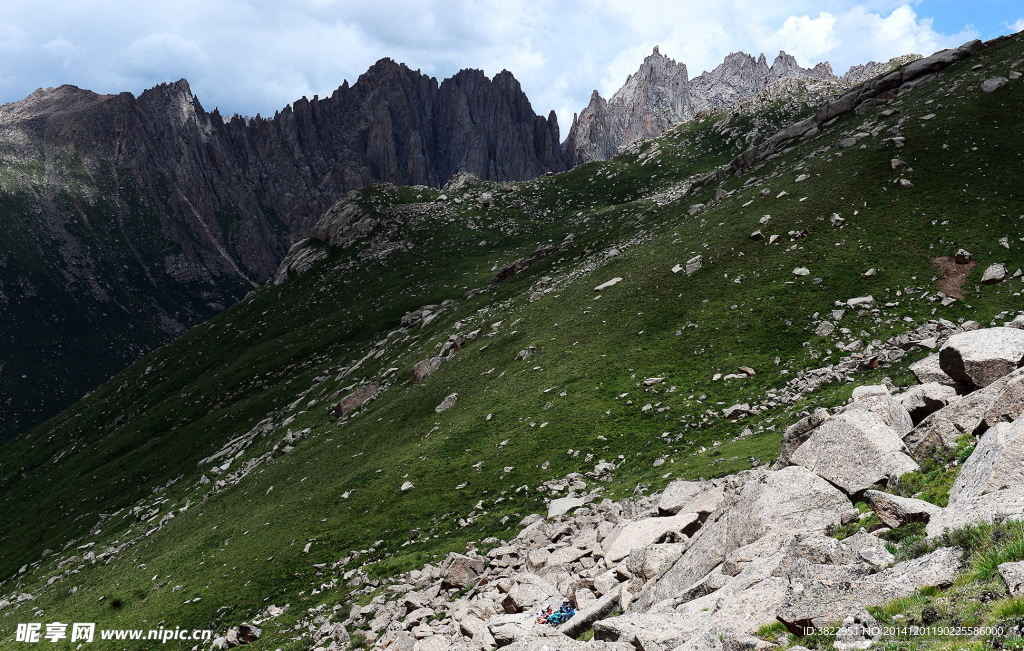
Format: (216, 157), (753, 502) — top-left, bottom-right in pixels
(0, 40), (1024, 649)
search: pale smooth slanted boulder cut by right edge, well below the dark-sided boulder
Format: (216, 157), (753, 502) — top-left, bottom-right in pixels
(949, 419), (1024, 505)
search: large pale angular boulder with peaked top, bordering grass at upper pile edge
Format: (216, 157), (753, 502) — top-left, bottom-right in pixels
(792, 407), (918, 495)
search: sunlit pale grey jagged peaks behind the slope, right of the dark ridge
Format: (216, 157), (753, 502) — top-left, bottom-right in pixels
(564, 46), (914, 165)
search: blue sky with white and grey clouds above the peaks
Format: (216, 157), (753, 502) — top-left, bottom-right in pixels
(0, 0), (1024, 132)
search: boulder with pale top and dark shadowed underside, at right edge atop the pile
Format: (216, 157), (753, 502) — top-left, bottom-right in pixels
(939, 328), (1024, 388)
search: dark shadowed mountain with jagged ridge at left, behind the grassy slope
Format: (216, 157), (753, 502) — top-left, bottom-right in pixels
(0, 59), (565, 437)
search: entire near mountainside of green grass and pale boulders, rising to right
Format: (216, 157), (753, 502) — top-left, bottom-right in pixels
(0, 35), (1024, 651)
